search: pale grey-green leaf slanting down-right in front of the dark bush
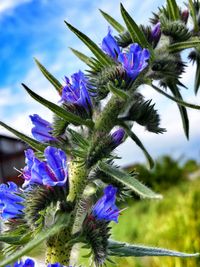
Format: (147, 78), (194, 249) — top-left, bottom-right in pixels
(98, 162), (162, 199)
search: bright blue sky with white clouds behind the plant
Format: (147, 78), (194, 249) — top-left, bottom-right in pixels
(0, 0), (200, 164)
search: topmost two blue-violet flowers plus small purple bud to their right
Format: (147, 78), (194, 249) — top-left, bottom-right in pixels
(101, 27), (150, 80)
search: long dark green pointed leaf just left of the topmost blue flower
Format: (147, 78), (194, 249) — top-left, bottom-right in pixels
(65, 21), (114, 66)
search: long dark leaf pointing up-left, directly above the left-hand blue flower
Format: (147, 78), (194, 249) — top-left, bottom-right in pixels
(22, 84), (93, 127)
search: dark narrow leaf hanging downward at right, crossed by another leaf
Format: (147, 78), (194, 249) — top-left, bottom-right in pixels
(168, 84), (189, 139)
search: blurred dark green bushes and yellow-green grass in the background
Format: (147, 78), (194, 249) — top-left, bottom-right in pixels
(82, 156), (200, 267)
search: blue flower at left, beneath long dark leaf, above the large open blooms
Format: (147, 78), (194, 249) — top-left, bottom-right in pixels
(29, 114), (56, 142)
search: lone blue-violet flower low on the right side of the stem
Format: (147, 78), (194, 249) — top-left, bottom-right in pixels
(92, 185), (119, 222)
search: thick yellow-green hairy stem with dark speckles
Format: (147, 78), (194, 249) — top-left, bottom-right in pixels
(46, 93), (130, 265)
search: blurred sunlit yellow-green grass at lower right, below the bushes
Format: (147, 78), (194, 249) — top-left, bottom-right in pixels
(108, 179), (200, 267)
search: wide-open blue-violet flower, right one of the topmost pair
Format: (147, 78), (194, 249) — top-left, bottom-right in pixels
(118, 43), (150, 80)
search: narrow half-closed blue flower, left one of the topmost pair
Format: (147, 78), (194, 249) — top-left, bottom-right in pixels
(101, 27), (120, 60)
